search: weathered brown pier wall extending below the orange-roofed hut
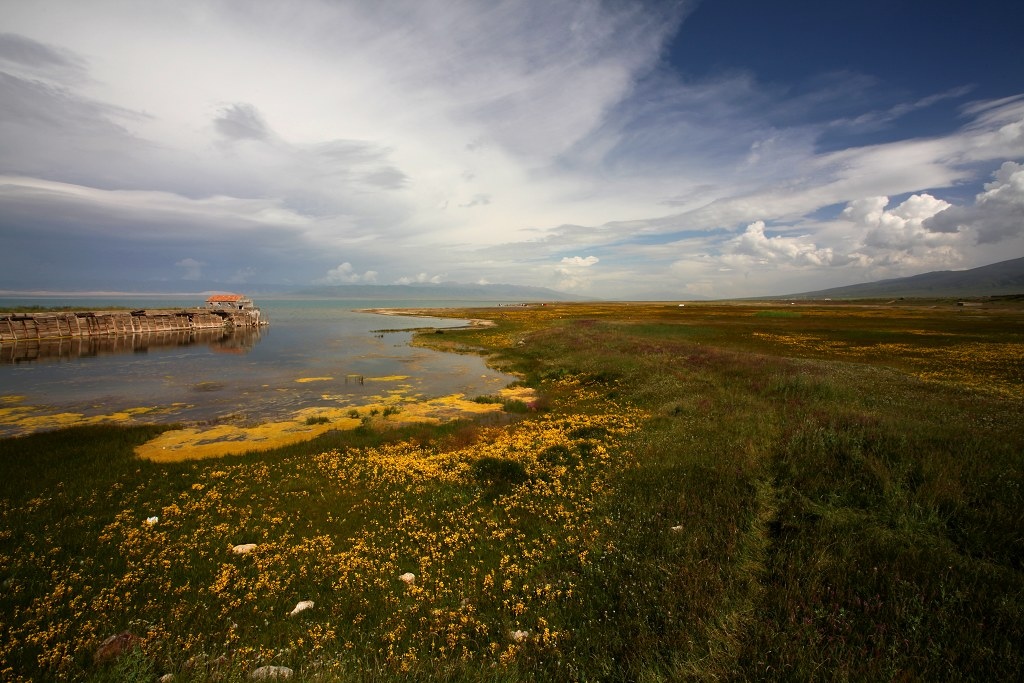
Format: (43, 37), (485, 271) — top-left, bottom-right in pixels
(0, 308), (265, 343)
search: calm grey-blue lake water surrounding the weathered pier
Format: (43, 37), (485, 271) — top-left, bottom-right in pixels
(0, 297), (515, 436)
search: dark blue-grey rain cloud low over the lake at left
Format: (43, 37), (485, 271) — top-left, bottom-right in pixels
(0, 180), (329, 289)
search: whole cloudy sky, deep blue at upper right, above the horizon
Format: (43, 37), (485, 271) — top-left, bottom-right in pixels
(0, 0), (1024, 299)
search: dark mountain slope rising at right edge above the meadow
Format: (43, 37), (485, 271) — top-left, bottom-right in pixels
(766, 258), (1024, 299)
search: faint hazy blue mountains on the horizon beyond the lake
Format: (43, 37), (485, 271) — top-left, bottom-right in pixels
(294, 283), (580, 301)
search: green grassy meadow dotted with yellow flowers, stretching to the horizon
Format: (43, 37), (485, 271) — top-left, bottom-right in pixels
(0, 302), (1024, 681)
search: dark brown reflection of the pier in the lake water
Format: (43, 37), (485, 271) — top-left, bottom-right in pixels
(0, 327), (263, 364)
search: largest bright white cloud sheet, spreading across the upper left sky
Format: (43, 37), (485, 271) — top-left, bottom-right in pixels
(0, 0), (682, 254)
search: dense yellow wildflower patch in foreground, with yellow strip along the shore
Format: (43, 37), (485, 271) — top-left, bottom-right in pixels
(0, 378), (645, 678)
